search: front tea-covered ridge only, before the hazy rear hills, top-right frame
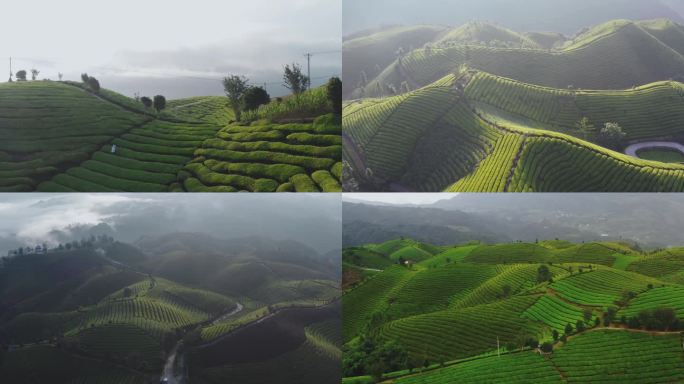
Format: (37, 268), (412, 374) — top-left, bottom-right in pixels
(343, 70), (684, 192)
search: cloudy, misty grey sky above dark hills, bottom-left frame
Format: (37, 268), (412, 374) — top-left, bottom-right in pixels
(0, 193), (342, 255)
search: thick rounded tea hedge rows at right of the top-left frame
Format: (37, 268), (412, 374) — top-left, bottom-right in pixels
(179, 116), (342, 192)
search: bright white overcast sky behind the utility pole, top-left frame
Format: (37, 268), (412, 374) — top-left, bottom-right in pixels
(0, 0), (342, 98)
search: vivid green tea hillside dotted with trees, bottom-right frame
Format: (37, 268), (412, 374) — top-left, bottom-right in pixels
(342, 239), (684, 383)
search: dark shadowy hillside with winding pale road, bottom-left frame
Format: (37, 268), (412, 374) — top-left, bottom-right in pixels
(0, 234), (340, 383)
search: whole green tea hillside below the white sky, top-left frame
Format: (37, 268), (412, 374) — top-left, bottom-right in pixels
(0, 81), (341, 192)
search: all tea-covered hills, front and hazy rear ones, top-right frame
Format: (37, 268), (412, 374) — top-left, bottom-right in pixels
(343, 21), (684, 192)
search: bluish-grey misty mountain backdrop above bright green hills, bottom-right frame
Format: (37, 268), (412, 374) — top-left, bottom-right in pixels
(343, 193), (684, 248)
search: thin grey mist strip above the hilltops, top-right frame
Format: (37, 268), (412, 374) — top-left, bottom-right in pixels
(342, 0), (684, 36)
